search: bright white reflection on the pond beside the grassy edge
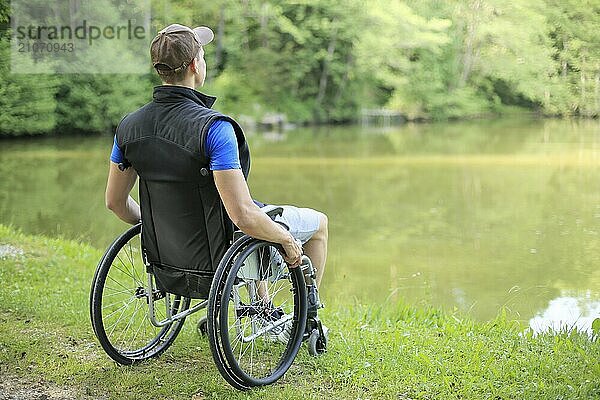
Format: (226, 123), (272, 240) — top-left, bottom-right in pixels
(529, 291), (600, 335)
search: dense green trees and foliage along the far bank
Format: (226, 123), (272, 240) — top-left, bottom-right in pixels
(0, 0), (600, 135)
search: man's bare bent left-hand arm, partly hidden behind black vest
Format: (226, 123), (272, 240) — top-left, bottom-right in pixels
(105, 161), (142, 224)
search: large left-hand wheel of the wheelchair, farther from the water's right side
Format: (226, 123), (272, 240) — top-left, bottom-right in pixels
(90, 224), (190, 365)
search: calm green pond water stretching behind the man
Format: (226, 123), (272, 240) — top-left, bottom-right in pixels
(0, 120), (600, 332)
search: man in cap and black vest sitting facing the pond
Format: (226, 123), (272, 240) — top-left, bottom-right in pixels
(106, 24), (328, 354)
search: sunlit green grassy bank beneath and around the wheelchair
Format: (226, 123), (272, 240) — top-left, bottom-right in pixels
(0, 225), (600, 399)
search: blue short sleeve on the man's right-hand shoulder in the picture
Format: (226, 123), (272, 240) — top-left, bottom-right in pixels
(206, 120), (242, 171)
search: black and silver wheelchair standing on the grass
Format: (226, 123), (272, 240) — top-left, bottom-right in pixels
(90, 209), (327, 390)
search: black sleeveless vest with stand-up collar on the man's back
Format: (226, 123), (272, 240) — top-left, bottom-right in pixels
(117, 86), (250, 298)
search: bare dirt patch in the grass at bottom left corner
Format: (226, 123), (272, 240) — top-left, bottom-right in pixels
(0, 375), (98, 400)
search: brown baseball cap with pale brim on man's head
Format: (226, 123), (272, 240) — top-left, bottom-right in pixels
(150, 24), (215, 74)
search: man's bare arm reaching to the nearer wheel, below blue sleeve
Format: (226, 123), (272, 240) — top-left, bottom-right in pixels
(213, 169), (302, 266)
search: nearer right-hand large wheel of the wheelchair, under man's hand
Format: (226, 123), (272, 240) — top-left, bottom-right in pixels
(208, 237), (307, 389)
